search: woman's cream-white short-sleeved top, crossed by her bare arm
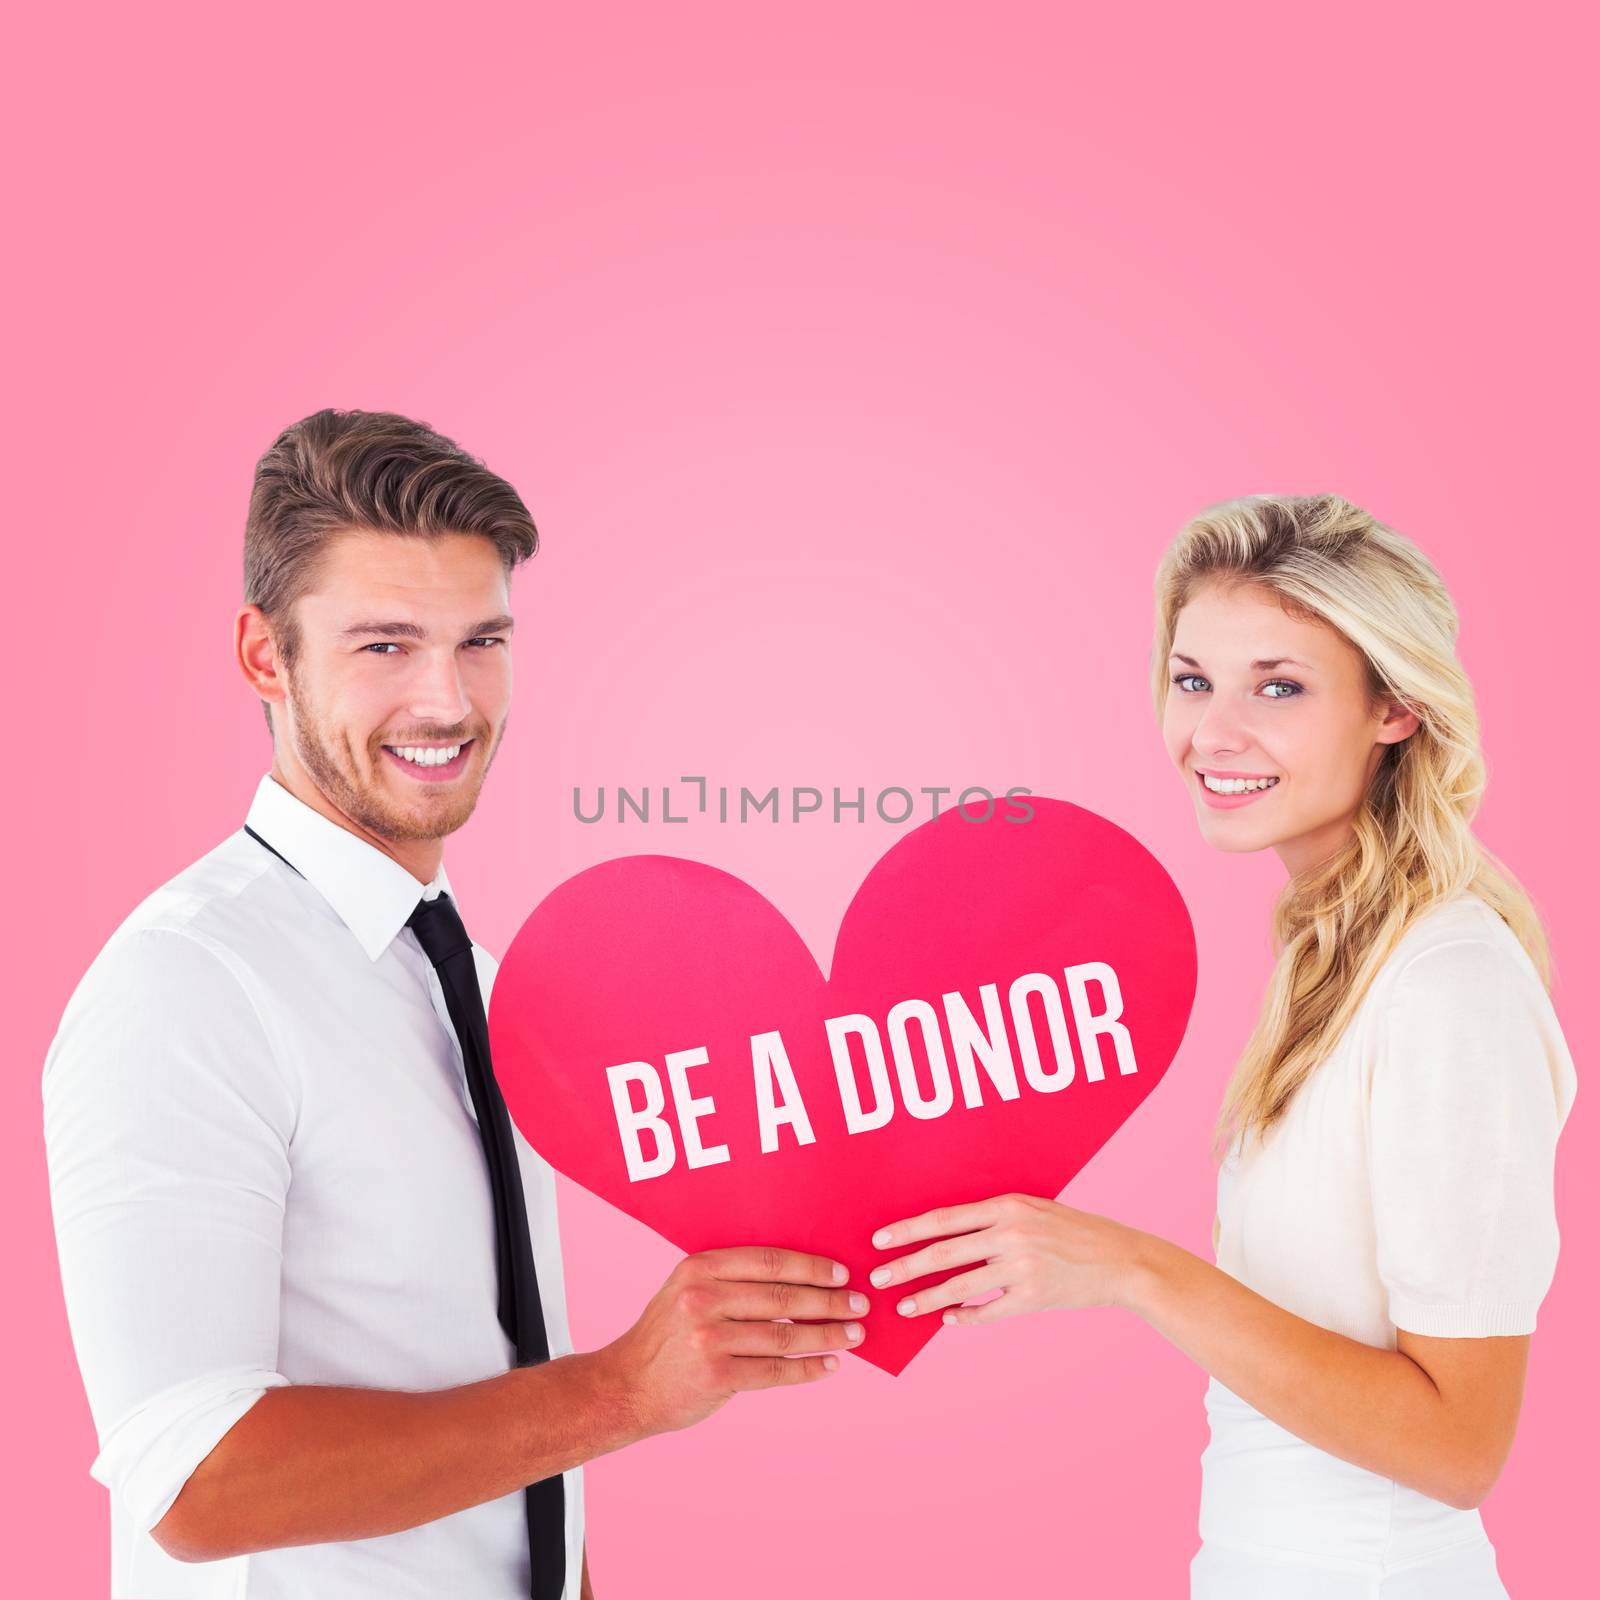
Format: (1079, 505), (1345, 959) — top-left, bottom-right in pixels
(1200, 893), (1576, 1594)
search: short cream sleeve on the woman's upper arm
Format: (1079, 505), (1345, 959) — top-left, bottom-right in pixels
(1370, 939), (1576, 1338)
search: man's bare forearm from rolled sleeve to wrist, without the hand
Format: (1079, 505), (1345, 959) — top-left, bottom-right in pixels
(152, 1352), (642, 1562)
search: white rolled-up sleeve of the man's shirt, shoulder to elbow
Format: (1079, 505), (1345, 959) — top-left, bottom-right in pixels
(43, 928), (296, 1530)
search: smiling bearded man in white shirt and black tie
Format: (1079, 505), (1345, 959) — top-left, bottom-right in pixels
(43, 411), (866, 1600)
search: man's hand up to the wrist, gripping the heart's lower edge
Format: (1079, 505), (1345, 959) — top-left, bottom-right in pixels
(597, 1245), (869, 1435)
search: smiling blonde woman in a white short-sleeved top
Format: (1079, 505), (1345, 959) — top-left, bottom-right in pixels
(872, 494), (1576, 1600)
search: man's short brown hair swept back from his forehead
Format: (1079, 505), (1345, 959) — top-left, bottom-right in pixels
(245, 410), (539, 728)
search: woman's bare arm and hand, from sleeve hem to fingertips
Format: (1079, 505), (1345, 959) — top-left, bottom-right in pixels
(872, 1195), (1530, 1509)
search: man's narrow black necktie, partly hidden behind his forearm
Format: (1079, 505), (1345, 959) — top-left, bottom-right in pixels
(406, 893), (566, 1600)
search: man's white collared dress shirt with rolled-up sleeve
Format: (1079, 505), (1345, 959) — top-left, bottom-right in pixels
(43, 776), (584, 1600)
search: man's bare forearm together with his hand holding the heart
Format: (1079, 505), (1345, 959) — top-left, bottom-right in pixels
(150, 1250), (867, 1561)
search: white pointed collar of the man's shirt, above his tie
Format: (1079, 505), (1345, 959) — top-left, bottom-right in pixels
(245, 773), (456, 962)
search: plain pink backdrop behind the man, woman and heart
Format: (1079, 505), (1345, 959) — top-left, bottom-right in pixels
(0, 3), (1597, 1600)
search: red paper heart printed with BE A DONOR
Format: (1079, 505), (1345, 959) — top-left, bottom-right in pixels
(490, 797), (1195, 1373)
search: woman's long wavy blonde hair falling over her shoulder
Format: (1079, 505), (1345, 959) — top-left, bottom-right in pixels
(1152, 494), (1550, 1154)
